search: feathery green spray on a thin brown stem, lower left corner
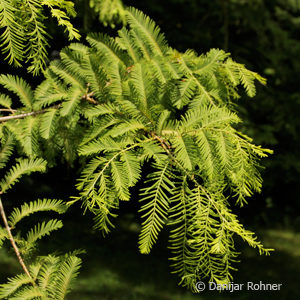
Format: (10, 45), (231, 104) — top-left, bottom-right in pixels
(0, 154), (81, 300)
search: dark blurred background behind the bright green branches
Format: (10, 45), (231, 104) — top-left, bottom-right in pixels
(0, 0), (300, 300)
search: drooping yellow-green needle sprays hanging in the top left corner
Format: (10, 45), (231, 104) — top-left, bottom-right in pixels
(0, 0), (80, 74)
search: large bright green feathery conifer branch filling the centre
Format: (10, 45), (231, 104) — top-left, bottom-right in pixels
(0, 9), (271, 290)
